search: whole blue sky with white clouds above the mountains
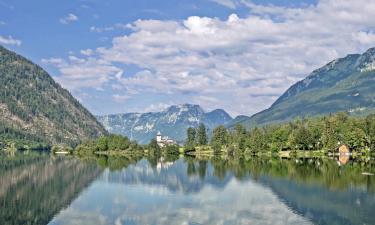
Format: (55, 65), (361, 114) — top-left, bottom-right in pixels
(0, 0), (375, 116)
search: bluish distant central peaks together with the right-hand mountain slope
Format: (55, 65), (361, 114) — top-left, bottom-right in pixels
(98, 48), (375, 143)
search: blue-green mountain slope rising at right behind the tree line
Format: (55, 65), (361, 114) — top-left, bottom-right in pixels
(241, 48), (375, 127)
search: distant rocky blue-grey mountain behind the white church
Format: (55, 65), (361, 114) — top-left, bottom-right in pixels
(97, 104), (232, 144)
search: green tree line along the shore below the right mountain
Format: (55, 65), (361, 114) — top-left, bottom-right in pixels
(185, 112), (375, 153)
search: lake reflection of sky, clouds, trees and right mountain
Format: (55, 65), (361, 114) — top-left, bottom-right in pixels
(51, 157), (375, 224)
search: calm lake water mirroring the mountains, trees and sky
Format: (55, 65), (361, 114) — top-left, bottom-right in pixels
(0, 153), (375, 225)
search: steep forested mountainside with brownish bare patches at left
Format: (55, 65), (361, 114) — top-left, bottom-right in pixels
(0, 46), (107, 147)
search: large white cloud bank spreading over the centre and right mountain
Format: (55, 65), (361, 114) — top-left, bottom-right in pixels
(47, 0), (375, 114)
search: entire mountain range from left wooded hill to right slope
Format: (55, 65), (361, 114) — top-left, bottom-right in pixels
(0, 46), (375, 145)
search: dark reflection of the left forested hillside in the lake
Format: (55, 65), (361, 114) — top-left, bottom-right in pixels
(0, 153), (100, 225)
